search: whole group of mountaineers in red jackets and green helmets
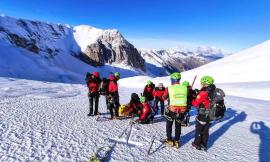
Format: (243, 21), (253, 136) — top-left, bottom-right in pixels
(86, 72), (226, 150)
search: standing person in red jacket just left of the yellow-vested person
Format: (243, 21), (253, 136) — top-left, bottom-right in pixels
(153, 83), (165, 116)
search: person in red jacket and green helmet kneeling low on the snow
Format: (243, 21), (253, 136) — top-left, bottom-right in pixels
(137, 96), (152, 124)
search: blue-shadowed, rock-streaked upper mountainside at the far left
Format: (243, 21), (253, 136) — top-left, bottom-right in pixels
(0, 17), (70, 57)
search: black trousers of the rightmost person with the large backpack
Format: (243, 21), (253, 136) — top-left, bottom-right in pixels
(194, 120), (211, 148)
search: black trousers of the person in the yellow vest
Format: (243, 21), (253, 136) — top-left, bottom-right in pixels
(165, 111), (184, 141)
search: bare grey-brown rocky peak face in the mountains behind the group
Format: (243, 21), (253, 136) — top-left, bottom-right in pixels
(75, 27), (145, 71)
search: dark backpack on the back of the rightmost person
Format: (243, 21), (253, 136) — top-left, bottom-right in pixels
(209, 88), (226, 121)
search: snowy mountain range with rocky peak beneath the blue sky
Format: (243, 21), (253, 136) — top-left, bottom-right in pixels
(0, 16), (223, 82)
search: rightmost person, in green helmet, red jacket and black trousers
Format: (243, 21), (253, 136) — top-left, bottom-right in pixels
(192, 76), (216, 150)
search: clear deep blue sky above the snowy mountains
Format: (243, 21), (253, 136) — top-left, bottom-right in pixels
(0, 0), (270, 52)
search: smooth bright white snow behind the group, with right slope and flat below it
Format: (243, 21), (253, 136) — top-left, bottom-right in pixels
(120, 41), (270, 100)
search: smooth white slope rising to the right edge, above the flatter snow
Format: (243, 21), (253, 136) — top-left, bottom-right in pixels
(180, 40), (270, 83)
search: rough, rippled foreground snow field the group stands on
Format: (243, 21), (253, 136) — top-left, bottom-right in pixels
(0, 79), (270, 162)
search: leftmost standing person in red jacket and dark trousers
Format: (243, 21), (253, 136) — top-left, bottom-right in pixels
(86, 72), (101, 116)
